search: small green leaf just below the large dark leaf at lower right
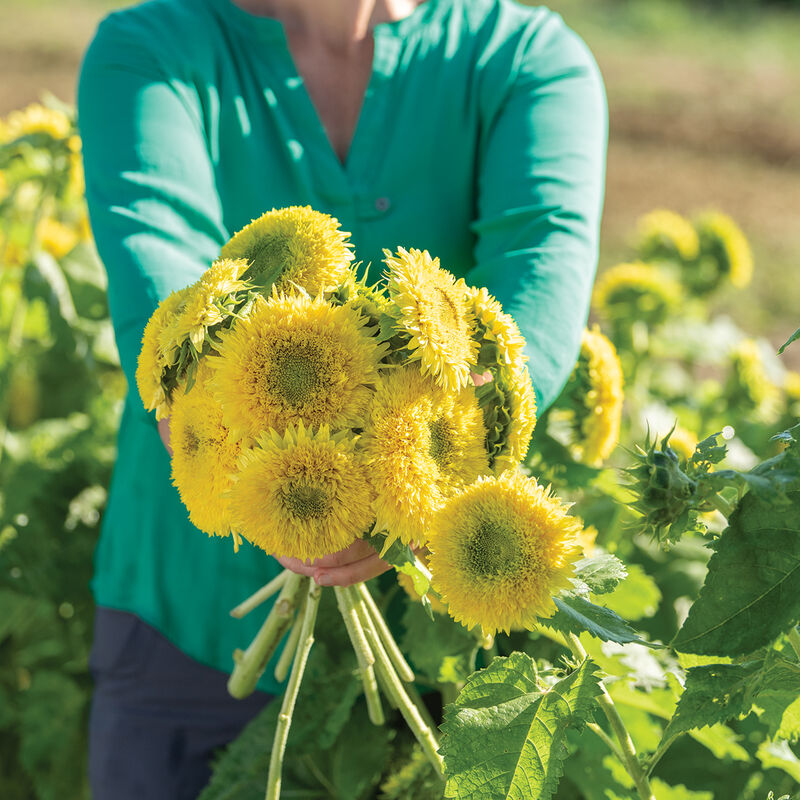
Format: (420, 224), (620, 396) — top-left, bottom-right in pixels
(664, 661), (762, 738)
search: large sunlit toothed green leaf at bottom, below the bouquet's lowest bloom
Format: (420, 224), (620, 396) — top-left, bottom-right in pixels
(441, 653), (601, 800)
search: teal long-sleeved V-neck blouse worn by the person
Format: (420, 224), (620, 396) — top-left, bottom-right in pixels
(78, 0), (606, 691)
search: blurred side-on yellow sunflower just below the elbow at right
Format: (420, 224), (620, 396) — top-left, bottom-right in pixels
(567, 326), (625, 467)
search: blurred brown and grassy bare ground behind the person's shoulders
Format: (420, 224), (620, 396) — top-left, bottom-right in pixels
(0, 0), (800, 361)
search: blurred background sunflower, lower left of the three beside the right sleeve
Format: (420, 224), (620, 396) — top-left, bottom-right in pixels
(592, 261), (683, 327)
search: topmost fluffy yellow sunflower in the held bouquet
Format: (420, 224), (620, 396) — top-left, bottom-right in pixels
(222, 206), (354, 297)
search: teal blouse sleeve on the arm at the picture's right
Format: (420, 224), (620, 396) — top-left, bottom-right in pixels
(466, 15), (607, 409)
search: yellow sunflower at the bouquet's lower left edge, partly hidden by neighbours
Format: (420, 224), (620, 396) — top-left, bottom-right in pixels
(169, 359), (241, 536)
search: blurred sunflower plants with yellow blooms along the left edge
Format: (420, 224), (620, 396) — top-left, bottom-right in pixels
(0, 100), (125, 800)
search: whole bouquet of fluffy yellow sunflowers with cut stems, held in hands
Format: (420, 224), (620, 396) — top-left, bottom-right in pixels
(136, 207), (582, 797)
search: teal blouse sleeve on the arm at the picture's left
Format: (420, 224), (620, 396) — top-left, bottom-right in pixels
(78, 16), (227, 406)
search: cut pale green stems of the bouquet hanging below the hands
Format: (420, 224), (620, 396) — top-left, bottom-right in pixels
(228, 570), (443, 800)
